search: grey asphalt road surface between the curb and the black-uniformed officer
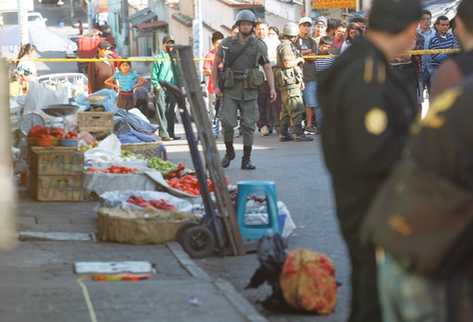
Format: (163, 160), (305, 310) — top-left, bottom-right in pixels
(166, 129), (350, 322)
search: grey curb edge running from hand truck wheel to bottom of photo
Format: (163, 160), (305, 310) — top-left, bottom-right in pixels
(166, 242), (268, 322)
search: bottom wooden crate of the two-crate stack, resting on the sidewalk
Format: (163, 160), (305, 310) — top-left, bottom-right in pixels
(31, 175), (84, 201)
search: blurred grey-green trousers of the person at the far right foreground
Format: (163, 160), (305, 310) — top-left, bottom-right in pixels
(377, 253), (473, 322)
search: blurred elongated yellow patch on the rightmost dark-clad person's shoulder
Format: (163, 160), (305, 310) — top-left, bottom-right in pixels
(421, 87), (462, 128)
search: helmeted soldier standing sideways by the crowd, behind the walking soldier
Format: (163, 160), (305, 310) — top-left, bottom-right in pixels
(275, 22), (315, 142)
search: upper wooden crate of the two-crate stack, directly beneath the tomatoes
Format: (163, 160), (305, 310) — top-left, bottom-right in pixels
(30, 147), (84, 177)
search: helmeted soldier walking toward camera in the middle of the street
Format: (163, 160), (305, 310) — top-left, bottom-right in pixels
(212, 10), (276, 170)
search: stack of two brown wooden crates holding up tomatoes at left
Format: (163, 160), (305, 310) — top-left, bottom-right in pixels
(30, 147), (84, 201)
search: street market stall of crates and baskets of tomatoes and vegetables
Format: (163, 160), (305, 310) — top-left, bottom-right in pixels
(13, 50), (295, 252)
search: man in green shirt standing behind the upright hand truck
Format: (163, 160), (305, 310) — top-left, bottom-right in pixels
(151, 36), (179, 141)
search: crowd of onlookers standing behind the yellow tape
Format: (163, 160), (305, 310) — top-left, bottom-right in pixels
(195, 4), (459, 169)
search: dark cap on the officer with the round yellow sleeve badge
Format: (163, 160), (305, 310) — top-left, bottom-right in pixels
(369, 0), (422, 34)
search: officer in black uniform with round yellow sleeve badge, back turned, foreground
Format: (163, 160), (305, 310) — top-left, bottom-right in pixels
(318, 0), (422, 322)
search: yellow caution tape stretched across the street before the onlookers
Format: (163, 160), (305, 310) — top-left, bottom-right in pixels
(5, 49), (460, 63)
